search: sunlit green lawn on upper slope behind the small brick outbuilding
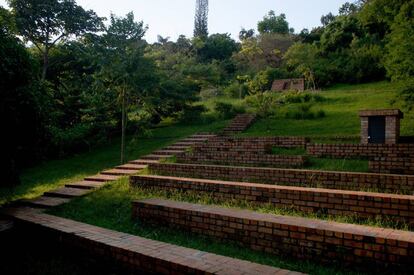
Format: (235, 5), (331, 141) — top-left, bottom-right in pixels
(243, 82), (414, 138)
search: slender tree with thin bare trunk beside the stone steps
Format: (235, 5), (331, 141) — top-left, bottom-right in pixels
(96, 12), (157, 163)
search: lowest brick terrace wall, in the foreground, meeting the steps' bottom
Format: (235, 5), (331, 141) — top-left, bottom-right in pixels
(7, 209), (300, 275)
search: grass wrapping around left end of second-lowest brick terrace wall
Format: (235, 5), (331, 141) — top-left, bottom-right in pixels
(50, 179), (378, 274)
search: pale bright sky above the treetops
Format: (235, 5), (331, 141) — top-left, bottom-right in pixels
(0, 0), (347, 42)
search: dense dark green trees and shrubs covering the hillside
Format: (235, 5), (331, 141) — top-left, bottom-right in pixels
(0, 0), (414, 185)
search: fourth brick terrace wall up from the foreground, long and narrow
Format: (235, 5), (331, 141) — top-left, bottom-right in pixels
(149, 163), (414, 195)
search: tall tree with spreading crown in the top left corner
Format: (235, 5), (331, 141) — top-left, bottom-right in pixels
(9, 0), (102, 80)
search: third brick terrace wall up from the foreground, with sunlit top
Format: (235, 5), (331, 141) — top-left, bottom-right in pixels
(130, 176), (414, 226)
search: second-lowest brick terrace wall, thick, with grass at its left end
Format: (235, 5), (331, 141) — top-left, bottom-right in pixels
(133, 199), (414, 274)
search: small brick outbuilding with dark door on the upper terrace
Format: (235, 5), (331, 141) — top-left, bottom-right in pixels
(359, 109), (404, 144)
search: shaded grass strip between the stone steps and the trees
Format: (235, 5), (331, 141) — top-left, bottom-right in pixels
(0, 121), (228, 206)
